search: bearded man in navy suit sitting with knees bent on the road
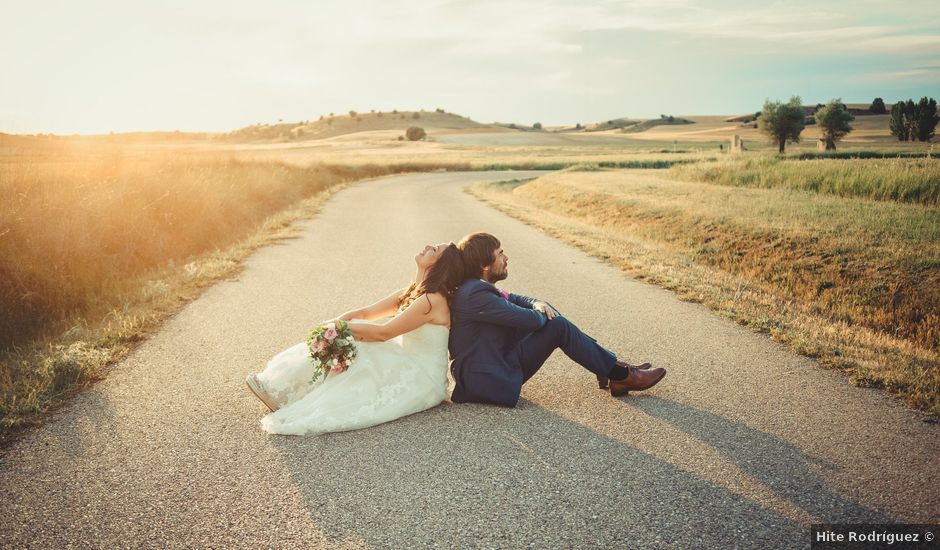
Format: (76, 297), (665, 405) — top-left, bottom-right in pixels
(448, 233), (666, 407)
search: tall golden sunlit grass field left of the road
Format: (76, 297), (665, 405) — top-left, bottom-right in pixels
(0, 140), (470, 432)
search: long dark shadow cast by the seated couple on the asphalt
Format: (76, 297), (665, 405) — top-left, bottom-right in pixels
(271, 396), (893, 547)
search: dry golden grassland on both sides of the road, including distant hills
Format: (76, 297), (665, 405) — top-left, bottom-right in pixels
(0, 111), (940, 438)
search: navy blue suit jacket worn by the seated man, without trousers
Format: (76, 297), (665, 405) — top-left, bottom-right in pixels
(448, 279), (547, 407)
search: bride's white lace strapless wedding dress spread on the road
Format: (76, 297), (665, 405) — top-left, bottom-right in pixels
(258, 320), (450, 435)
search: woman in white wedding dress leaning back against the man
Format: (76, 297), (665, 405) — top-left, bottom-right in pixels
(245, 243), (463, 435)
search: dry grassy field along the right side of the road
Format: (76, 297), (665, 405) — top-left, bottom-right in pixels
(472, 170), (940, 415)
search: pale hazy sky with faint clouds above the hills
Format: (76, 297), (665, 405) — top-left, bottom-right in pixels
(0, 0), (940, 134)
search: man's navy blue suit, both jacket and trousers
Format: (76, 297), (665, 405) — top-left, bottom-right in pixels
(449, 279), (617, 407)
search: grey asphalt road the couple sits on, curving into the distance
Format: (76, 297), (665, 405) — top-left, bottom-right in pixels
(0, 173), (940, 548)
